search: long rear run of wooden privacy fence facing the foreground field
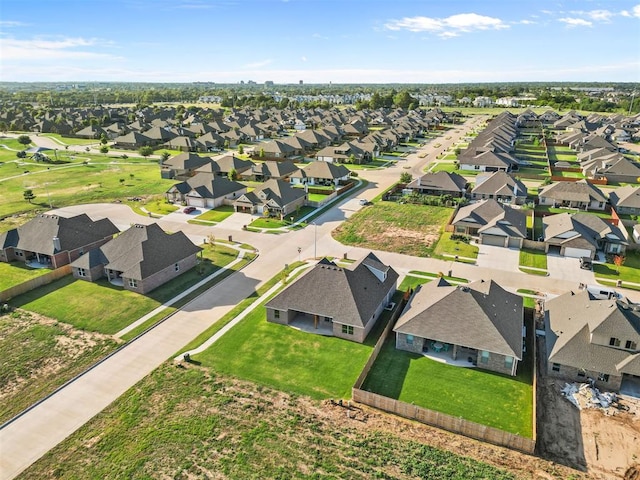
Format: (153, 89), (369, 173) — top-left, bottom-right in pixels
(353, 388), (536, 454)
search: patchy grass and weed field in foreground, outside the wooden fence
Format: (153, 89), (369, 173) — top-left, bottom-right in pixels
(19, 364), (516, 480)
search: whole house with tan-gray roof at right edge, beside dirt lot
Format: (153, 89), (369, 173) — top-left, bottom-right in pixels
(544, 289), (640, 393)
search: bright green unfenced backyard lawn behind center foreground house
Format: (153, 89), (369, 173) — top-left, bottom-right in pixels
(192, 306), (372, 399)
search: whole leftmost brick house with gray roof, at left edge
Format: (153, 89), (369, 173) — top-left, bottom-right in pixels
(0, 213), (120, 269)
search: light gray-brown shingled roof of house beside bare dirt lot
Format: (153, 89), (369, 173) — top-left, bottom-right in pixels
(545, 290), (640, 375)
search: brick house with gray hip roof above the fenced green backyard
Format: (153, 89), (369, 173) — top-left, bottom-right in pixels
(393, 279), (524, 376)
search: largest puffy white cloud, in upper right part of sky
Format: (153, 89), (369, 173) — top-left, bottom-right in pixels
(385, 13), (509, 38)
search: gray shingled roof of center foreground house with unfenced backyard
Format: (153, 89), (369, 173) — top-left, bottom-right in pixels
(265, 253), (398, 328)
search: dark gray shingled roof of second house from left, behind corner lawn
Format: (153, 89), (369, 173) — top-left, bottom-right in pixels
(71, 223), (202, 280)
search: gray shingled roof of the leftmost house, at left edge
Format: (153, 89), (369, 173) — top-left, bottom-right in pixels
(0, 213), (120, 255)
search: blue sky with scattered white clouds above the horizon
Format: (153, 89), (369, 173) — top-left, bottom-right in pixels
(0, 0), (640, 83)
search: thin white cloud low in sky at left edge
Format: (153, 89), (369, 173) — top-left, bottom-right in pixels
(0, 37), (114, 61)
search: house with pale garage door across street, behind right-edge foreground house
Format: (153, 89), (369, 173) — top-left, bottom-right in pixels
(542, 213), (629, 258)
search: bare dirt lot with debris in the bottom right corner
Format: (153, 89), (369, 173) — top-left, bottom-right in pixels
(537, 336), (640, 480)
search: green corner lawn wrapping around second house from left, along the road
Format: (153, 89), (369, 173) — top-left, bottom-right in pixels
(11, 246), (236, 334)
